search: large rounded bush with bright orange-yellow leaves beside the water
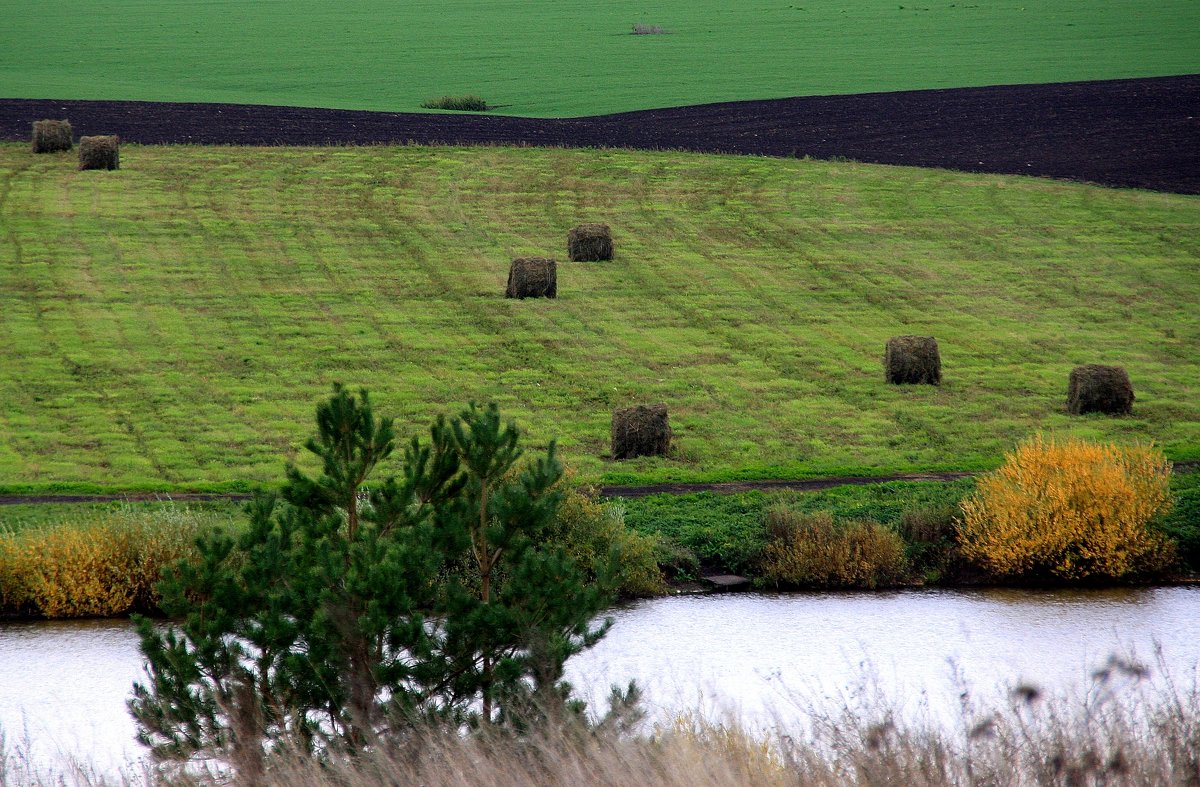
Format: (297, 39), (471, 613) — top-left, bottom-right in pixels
(956, 435), (1175, 579)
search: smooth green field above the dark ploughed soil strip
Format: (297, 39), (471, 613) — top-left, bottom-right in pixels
(0, 0), (1200, 116)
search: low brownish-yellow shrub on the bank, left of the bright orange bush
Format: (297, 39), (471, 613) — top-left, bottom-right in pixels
(758, 506), (905, 588)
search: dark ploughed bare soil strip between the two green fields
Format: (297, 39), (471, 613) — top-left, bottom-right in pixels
(0, 74), (1200, 194)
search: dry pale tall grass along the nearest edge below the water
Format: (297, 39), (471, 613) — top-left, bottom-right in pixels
(0, 656), (1200, 787)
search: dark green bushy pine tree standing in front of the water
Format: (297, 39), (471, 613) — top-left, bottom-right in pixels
(130, 385), (619, 783)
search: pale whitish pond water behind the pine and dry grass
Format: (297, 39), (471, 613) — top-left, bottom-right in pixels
(0, 587), (1200, 773)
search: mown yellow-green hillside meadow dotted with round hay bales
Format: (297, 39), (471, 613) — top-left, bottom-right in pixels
(0, 144), (1200, 488)
